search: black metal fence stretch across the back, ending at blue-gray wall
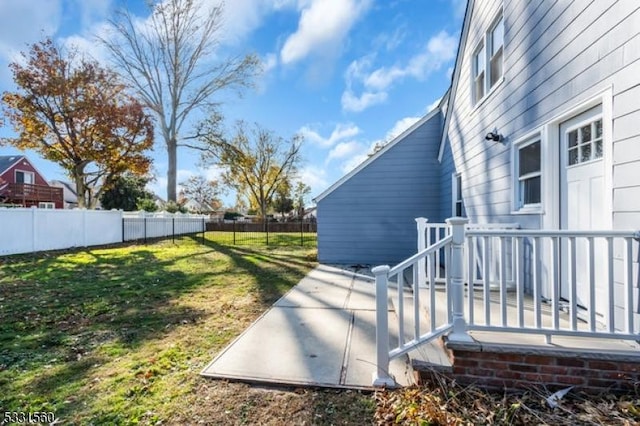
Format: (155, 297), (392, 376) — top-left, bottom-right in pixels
(207, 221), (317, 247)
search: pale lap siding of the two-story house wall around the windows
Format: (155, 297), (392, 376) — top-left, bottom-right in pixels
(447, 0), (640, 326)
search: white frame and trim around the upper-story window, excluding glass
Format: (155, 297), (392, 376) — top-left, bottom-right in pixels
(471, 9), (504, 106)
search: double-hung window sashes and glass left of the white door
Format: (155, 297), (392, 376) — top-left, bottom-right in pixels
(515, 137), (542, 210)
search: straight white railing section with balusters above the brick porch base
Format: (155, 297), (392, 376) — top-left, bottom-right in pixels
(465, 229), (640, 340)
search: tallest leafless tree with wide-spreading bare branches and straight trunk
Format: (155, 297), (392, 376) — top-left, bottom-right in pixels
(100, 0), (260, 201)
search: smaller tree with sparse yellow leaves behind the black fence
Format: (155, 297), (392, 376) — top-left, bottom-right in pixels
(199, 117), (302, 226)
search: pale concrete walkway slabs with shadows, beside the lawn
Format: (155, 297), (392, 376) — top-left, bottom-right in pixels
(201, 265), (413, 388)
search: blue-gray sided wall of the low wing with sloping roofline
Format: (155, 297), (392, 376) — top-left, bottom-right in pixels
(317, 114), (442, 265)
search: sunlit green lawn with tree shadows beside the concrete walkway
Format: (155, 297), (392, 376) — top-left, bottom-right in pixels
(0, 234), (375, 424)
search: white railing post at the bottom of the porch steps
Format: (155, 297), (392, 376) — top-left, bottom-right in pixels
(371, 265), (395, 387)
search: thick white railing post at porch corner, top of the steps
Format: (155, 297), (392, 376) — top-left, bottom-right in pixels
(446, 217), (473, 342)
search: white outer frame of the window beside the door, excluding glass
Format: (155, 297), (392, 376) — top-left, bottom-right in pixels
(511, 129), (545, 214)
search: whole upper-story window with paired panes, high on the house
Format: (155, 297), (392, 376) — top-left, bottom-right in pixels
(472, 11), (504, 104)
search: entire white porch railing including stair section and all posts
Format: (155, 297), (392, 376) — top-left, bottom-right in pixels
(373, 218), (640, 386)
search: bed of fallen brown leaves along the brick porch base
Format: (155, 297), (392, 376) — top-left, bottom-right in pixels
(375, 377), (640, 425)
